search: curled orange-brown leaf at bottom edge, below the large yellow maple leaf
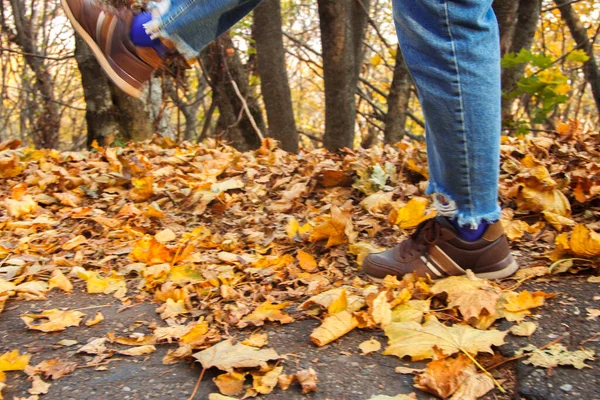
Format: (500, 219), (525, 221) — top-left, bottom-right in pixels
(415, 353), (476, 399)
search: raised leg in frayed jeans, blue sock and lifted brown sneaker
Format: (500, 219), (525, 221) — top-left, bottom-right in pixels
(61, 0), (261, 97)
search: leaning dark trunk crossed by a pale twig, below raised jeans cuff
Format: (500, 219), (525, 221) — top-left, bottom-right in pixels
(202, 33), (265, 151)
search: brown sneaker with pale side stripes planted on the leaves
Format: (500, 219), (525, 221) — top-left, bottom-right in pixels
(363, 217), (519, 279)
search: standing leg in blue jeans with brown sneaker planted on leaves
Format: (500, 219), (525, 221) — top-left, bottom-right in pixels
(363, 0), (518, 278)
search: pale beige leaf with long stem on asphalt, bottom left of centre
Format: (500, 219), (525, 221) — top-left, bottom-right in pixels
(194, 340), (279, 372)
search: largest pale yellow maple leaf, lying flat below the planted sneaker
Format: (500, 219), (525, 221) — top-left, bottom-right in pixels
(383, 316), (506, 361)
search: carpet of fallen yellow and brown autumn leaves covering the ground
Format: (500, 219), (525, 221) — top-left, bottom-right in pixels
(0, 123), (600, 399)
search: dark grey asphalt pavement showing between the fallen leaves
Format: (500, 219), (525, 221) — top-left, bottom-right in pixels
(0, 276), (600, 400)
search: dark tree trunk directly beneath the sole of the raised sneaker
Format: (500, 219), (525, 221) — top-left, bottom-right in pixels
(75, 35), (119, 147)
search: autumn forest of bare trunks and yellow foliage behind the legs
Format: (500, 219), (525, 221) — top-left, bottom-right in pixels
(0, 0), (600, 152)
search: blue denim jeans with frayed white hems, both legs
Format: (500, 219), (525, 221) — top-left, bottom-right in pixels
(147, 0), (501, 226)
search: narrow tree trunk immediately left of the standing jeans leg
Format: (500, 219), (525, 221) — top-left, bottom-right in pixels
(384, 47), (412, 144)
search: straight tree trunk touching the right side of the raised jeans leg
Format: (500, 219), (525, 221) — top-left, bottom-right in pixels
(254, 0), (298, 153)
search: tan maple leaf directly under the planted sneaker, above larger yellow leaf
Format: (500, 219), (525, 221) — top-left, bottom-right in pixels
(431, 271), (501, 320)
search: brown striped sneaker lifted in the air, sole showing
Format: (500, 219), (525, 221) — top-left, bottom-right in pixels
(61, 0), (162, 98)
